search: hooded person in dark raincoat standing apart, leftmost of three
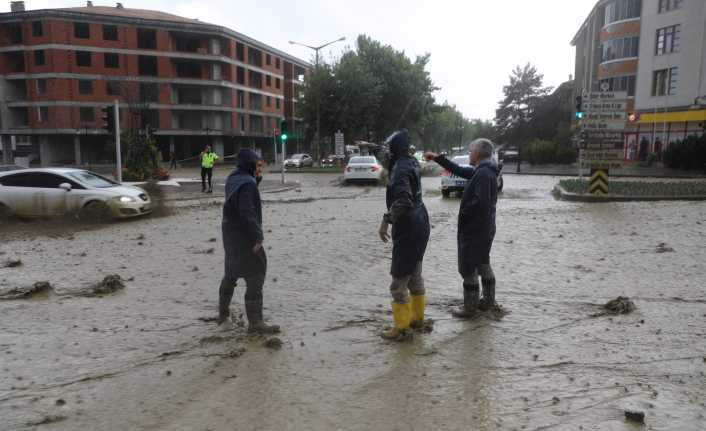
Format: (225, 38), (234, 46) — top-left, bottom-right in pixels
(218, 149), (279, 333)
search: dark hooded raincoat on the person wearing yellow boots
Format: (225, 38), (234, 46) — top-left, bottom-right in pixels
(385, 130), (430, 278)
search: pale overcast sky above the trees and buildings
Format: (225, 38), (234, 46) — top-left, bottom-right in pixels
(0, 0), (596, 119)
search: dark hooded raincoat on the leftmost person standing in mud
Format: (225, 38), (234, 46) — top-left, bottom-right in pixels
(222, 149), (267, 279)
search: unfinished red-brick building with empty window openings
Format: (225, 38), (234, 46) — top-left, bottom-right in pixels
(0, 2), (310, 165)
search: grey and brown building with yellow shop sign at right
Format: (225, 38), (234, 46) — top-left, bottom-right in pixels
(571, 0), (706, 160)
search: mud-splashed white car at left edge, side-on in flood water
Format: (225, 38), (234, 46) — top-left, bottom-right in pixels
(0, 168), (152, 218)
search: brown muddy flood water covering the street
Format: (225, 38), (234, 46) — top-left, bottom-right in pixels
(0, 174), (706, 431)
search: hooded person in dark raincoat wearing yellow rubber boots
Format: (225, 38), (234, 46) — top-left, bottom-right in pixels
(378, 129), (430, 339)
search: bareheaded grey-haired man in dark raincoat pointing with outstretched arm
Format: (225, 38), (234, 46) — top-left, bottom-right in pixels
(425, 138), (500, 318)
